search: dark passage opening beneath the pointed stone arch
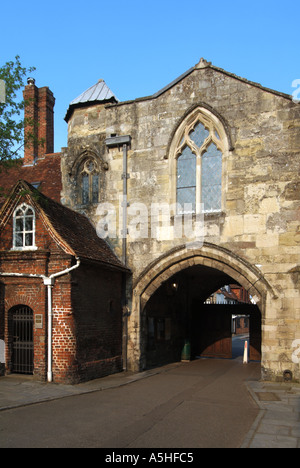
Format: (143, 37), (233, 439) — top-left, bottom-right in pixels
(142, 265), (261, 368)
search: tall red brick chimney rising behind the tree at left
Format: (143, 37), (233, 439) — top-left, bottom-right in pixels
(23, 78), (55, 166)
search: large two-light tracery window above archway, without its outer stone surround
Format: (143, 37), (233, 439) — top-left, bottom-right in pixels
(175, 112), (223, 213)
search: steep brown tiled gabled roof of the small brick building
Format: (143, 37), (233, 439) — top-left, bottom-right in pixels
(0, 180), (129, 272)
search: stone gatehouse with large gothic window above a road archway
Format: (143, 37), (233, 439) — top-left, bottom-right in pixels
(1, 59), (300, 381)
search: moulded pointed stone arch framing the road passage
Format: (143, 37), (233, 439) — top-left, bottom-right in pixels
(128, 243), (277, 370)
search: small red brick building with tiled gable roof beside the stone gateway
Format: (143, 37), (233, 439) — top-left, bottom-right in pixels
(0, 181), (128, 383)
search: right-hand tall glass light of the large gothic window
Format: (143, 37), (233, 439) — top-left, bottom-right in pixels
(201, 144), (222, 211)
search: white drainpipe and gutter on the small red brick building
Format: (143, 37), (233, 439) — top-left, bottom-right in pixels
(0, 257), (80, 382)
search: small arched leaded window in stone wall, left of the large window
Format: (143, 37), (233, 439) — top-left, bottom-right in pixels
(80, 158), (100, 205)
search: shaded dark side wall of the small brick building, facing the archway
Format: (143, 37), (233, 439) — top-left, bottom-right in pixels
(72, 264), (122, 380)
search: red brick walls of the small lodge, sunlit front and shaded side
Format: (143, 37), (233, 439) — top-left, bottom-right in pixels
(0, 197), (122, 383)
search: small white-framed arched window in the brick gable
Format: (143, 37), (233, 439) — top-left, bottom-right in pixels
(13, 203), (35, 249)
